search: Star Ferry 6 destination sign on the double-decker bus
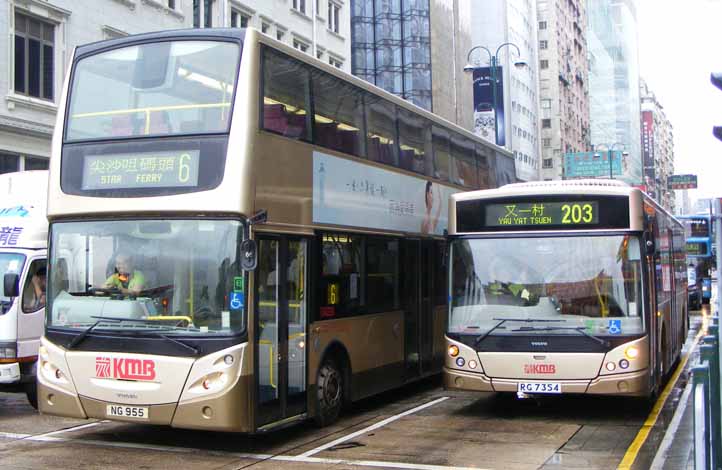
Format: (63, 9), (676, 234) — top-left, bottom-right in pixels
(81, 150), (200, 190)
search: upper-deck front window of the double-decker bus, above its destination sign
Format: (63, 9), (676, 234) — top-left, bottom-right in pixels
(66, 41), (241, 141)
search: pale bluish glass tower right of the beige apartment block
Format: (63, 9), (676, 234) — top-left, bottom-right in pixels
(586, 0), (643, 184)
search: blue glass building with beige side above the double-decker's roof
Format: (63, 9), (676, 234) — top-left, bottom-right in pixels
(351, 0), (473, 129)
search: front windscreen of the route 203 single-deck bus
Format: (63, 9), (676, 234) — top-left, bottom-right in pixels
(449, 235), (643, 335)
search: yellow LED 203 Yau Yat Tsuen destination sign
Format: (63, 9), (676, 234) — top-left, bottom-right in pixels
(485, 201), (599, 228)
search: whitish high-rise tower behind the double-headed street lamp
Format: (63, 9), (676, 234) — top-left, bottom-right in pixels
(470, 0), (550, 181)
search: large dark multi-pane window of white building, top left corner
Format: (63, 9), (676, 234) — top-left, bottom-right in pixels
(14, 11), (55, 101)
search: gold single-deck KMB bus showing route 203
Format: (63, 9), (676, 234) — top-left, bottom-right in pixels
(444, 180), (689, 397)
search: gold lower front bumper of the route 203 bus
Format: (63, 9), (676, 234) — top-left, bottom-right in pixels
(444, 367), (649, 396)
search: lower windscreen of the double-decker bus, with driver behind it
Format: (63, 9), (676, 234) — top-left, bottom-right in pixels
(48, 220), (245, 334)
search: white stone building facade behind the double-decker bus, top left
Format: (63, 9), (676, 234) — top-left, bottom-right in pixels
(0, 0), (351, 173)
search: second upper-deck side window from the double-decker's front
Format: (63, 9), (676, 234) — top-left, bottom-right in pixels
(311, 70), (365, 157)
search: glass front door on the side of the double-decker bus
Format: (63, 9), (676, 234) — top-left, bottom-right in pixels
(255, 236), (308, 428)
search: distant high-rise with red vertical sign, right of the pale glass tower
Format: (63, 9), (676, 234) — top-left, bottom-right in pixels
(639, 80), (676, 210)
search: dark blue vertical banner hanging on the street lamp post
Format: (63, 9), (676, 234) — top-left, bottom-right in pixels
(474, 67), (506, 147)
